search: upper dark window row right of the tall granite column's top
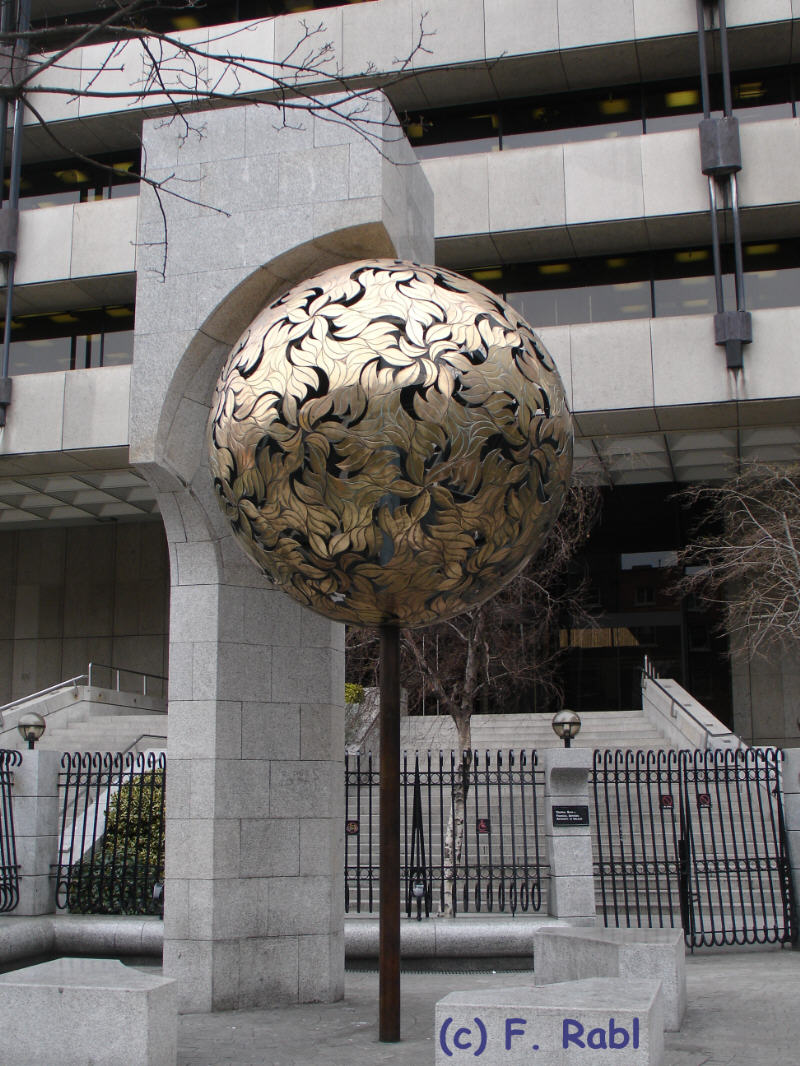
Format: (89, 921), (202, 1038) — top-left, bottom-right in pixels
(403, 66), (800, 159)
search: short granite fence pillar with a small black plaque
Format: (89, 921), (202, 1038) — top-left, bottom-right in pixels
(540, 747), (596, 925)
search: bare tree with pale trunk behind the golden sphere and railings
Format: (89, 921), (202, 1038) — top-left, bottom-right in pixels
(348, 482), (601, 915)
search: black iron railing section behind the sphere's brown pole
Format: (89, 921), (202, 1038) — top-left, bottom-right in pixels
(345, 752), (549, 917)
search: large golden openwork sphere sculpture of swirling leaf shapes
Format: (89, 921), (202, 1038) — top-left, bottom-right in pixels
(208, 259), (572, 627)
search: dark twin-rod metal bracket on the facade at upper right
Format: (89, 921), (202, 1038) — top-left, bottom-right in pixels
(695, 0), (753, 370)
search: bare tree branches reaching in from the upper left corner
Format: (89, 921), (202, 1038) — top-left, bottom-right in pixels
(0, 0), (429, 268)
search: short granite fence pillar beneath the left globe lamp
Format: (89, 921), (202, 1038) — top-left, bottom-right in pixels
(12, 749), (61, 916)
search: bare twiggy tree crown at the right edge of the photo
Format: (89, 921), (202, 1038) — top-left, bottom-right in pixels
(676, 464), (800, 656)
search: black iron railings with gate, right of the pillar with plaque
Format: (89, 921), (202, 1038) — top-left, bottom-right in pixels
(593, 748), (797, 948)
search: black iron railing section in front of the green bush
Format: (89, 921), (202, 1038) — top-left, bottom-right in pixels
(55, 753), (166, 915)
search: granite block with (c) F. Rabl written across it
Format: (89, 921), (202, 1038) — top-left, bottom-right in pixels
(435, 978), (663, 1066)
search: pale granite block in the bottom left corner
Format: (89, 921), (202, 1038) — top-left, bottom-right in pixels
(0, 958), (178, 1066)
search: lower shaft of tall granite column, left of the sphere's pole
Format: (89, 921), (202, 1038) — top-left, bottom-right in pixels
(162, 490), (345, 1011)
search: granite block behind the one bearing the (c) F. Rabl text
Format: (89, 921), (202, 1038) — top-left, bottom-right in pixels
(533, 928), (686, 1032)
